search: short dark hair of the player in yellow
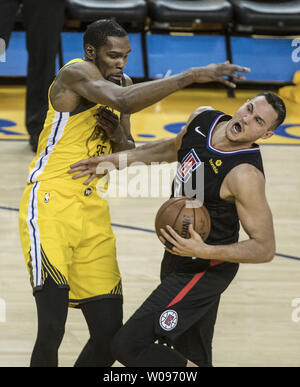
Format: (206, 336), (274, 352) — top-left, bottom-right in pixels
(83, 19), (127, 50)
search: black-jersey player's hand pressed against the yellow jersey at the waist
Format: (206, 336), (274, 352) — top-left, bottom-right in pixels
(68, 154), (116, 185)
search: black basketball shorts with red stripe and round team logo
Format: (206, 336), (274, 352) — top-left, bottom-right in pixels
(128, 262), (239, 342)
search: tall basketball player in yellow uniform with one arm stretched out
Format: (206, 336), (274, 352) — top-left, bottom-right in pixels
(20, 20), (248, 366)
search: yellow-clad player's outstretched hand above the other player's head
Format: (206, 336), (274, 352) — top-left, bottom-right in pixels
(191, 61), (251, 88)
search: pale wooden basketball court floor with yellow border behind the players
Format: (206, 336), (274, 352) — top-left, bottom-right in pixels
(0, 87), (300, 367)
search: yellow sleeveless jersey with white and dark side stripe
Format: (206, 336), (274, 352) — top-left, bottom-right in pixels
(27, 59), (119, 189)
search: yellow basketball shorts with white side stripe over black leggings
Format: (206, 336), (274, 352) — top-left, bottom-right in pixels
(19, 179), (122, 307)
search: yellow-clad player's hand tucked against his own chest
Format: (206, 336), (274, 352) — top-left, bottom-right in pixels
(95, 106), (124, 143)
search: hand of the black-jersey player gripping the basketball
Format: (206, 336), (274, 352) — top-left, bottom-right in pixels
(159, 224), (209, 259)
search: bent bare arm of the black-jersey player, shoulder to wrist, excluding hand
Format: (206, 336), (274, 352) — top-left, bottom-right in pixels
(208, 164), (275, 263)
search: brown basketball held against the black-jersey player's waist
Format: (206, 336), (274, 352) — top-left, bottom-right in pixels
(155, 197), (211, 241)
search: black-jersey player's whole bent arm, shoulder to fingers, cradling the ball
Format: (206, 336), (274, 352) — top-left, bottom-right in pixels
(161, 164), (275, 263)
